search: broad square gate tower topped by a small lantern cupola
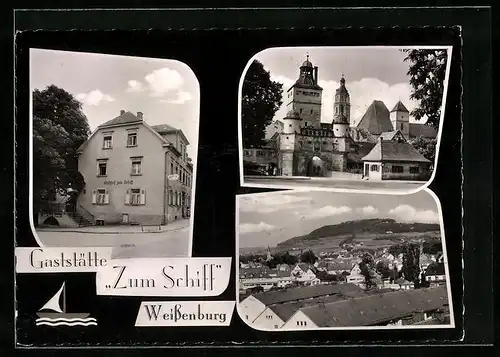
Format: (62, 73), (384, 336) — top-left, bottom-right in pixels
(285, 55), (323, 129)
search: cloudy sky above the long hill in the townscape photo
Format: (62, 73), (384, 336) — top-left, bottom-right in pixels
(237, 191), (440, 248)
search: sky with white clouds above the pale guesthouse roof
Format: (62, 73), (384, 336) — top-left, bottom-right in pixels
(30, 49), (200, 162)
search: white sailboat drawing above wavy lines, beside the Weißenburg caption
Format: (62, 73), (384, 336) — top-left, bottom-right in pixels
(36, 282), (97, 326)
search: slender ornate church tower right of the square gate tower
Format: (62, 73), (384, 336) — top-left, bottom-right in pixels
(333, 75), (351, 152)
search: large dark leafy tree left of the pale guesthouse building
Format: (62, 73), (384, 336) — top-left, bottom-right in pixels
(33, 85), (90, 223)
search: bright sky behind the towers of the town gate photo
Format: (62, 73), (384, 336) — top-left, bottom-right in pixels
(249, 47), (450, 131)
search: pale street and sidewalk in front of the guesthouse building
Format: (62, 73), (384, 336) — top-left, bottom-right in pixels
(36, 219), (190, 258)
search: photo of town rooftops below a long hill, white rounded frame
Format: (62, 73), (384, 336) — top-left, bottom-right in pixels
(236, 189), (455, 332)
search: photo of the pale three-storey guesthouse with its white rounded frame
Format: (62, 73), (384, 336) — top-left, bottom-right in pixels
(29, 48), (200, 262)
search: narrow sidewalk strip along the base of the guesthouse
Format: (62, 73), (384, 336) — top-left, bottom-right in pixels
(36, 219), (190, 234)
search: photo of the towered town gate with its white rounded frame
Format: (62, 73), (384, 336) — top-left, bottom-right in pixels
(239, 46), (452, 194)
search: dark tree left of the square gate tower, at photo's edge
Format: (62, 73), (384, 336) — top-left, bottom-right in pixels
(241, 60), (283, 147)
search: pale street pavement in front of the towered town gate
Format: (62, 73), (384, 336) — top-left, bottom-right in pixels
(245, 177), (426, 193)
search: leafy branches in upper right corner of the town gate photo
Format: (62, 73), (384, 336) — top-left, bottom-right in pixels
(402, 49), (448, 128)
